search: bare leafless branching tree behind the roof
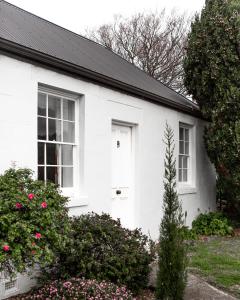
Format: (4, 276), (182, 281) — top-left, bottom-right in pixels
(87, 10), (189, 93)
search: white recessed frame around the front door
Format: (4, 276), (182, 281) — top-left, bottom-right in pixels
(111, 119), (138, 229)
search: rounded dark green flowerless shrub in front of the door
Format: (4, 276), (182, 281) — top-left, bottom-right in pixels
(44, 213), (152, 292)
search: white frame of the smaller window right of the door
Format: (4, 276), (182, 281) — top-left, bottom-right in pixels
(177, 122), (196, 194)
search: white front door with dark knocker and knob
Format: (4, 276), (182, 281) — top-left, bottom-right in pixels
(112, 124), (134, 228)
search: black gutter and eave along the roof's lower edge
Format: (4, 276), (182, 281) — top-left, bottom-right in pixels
(0, 38), (203, 119)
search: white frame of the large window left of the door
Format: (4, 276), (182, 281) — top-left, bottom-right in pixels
(37, 86), (80, 202)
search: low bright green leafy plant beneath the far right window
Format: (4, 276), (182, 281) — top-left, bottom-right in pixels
(192, 212), (233, 236)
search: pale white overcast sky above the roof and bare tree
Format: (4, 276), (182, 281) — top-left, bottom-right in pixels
(8, 0), (205, 33)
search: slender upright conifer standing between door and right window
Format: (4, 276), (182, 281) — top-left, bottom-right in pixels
(156, 125), (187, 300)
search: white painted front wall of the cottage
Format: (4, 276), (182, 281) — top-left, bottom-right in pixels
(0, 55), (215, 296)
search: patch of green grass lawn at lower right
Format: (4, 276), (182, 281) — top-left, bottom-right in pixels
(190, 237), (240, 298)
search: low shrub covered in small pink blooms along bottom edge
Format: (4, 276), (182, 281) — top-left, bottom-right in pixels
(11, 278), (133, 300)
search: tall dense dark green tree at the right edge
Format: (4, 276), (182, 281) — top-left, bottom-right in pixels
(184, 0), (240, 208)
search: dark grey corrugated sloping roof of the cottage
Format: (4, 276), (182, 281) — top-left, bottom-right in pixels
(0, 0), (198, 115)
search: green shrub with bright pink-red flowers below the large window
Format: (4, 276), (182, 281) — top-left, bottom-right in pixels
(0, 169), (68, 274)
